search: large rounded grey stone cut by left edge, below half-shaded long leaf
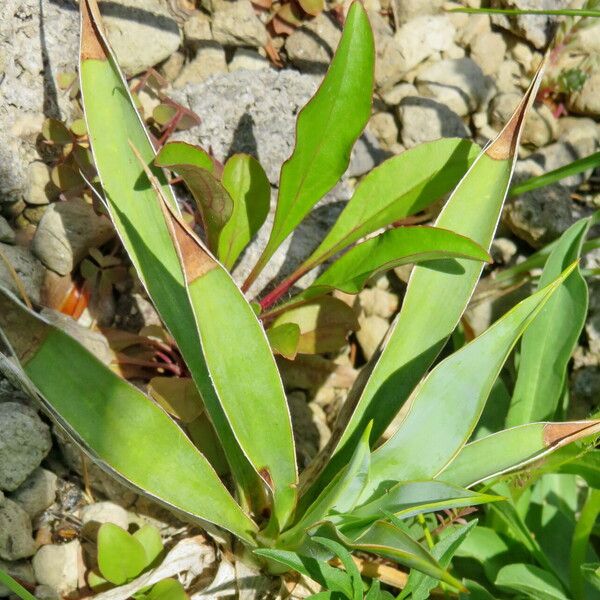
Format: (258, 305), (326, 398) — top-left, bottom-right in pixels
(0, 402), (52, 492)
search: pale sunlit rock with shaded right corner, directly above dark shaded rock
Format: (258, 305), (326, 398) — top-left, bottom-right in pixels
(415, 58), (490, 116)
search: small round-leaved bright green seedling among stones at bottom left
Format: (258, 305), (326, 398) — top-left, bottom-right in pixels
(88, 523), (187, 600)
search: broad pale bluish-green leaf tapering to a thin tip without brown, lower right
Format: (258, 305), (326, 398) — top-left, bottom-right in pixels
(370, 265), (575, 489)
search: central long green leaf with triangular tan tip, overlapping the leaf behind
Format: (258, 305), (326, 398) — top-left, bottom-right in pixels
(150, 165), (297, 527)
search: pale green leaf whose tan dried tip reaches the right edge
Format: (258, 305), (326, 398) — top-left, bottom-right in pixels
(436, 421), (600, 487)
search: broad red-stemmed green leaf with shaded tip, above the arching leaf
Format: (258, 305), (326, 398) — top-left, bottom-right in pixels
(292, 138), (480, 282)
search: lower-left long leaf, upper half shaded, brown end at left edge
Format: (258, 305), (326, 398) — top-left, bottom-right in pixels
(0, 288), (256, 542)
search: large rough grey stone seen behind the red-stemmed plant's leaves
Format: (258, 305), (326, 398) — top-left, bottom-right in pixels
(175, 69), (385, 293)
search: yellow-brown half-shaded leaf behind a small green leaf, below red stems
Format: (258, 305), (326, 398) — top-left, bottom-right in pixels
(272, 296), (359, 354)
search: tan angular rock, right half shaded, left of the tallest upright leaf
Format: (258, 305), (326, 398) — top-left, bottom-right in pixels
(32, 199), (114, 275)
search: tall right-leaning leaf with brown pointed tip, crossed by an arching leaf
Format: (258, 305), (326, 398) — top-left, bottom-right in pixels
(302, 57), (543, 510)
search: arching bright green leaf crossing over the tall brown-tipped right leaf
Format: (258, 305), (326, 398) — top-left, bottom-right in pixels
(299, 226), (491, 299)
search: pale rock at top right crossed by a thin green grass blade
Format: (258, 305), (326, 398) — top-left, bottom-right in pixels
(492, 0), (570, 49)
